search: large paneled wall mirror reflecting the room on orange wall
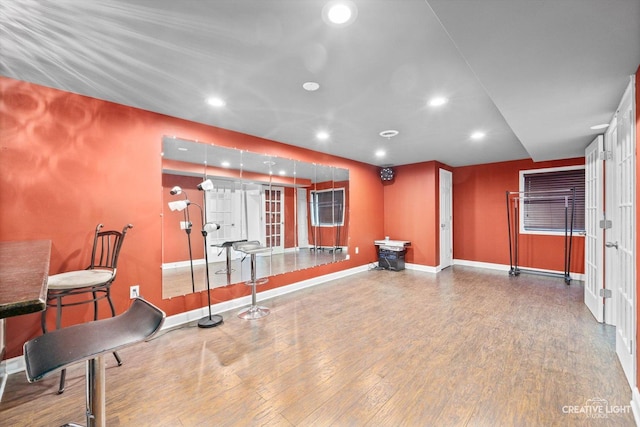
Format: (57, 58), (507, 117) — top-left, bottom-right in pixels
(162, 136), (349, 298)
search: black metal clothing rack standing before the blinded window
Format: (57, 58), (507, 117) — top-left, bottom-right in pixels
(506, 187), (576, 285)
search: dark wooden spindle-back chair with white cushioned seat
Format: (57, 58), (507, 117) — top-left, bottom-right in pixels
(42, 224), (133, 393)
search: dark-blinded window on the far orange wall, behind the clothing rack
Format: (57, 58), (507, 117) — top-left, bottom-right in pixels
(521, 168), (585, 233)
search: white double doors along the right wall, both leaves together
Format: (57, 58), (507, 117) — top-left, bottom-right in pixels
(584, 76), (636, 387)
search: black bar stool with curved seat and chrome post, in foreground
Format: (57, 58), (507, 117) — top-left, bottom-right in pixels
(24, 298), (165, 427)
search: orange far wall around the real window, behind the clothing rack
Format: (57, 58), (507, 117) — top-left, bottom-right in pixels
(453, 158), (584, 273)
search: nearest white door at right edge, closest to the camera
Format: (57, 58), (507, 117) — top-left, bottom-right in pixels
(607, 79), (636, 388)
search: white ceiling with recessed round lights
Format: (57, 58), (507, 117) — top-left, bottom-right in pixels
(0, 0), (640, 166)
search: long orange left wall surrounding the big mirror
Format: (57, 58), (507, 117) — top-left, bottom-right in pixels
(0, 77), (383, 358)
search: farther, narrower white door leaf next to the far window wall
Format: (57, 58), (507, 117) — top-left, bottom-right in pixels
(584, 136), (604, 323)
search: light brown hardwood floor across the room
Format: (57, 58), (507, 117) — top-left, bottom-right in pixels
(0, 266), (634, 426)
